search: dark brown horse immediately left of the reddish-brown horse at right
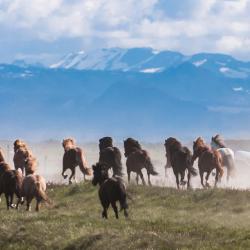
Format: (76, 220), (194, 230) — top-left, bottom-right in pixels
(164, 137), (197, 189)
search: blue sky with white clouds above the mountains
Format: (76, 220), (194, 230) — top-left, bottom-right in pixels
(0, 0), (250, 64)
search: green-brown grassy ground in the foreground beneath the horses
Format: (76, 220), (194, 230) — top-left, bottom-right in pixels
(0, 183), (250, 249)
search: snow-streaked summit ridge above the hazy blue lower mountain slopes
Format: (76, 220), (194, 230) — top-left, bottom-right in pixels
(50, 48), (250, 79)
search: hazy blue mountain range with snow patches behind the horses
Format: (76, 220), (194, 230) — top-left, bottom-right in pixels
(0, 48), (250, 141)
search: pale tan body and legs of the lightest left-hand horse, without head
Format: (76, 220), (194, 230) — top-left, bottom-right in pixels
(21, 174), (50, 212)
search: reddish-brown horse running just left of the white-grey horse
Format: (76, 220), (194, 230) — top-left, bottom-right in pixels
(192, 137), (223, 187)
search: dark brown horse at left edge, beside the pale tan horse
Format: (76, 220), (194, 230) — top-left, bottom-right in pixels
(0, 162), (23, 210)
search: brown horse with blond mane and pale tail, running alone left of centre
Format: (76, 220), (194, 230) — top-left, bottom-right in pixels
(62, 139), (91, 184)
